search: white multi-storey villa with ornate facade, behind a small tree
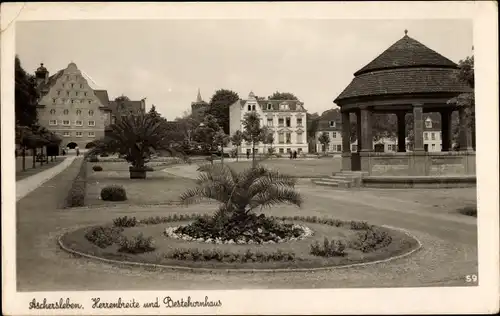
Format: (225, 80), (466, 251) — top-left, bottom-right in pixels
(229, 92), (308, 154)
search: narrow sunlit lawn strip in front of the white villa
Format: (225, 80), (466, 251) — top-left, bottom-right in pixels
(227, 158), (342, 178)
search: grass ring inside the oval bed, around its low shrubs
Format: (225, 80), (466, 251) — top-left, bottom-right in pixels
(58, 218), (418, 269)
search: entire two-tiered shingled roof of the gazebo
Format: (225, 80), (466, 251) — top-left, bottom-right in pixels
(334, 34), (471, 104)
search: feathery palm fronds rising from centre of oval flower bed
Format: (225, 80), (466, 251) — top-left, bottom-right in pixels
(180, 165), (302, 219)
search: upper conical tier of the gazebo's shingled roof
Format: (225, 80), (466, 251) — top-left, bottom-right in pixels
(354, 35), (458, 76)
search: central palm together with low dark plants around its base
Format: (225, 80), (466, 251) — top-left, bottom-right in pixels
(180, 164), (303, 241)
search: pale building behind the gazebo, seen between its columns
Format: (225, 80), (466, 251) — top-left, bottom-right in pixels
(316, 109), (441, 154)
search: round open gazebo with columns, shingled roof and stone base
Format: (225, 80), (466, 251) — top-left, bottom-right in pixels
(334, 30), (476, 177)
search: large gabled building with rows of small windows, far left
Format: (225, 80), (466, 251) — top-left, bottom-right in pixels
(35, 62), (111, 148)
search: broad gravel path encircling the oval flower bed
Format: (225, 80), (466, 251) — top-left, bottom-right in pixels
(17, 165), (477, 291)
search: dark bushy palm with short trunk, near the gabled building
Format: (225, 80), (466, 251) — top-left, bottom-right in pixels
(88, 114), (185, 178)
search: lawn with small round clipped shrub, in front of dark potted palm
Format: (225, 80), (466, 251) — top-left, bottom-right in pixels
(85, 162), (195, 205)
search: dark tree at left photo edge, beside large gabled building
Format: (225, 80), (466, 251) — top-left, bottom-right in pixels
(14, 56), (40, 128)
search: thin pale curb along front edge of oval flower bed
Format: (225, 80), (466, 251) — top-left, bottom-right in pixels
(57, 225), (422, 273)
